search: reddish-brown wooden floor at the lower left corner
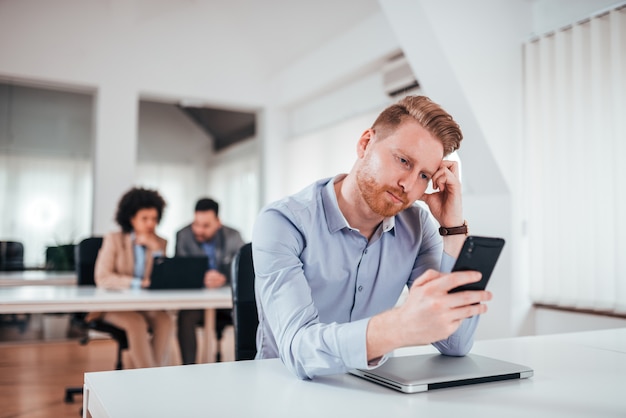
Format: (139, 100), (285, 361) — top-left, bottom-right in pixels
(0, 340), (116, 418)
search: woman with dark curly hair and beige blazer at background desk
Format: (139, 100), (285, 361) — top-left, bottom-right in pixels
(95, 188), (174, 368)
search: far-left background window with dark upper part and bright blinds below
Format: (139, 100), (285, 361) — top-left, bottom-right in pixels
(0, 84), (93, 268)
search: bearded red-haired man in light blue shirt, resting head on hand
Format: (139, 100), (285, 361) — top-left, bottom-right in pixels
(252, 96), (491, 379)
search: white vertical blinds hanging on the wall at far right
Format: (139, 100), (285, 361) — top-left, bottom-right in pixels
(524, 5), (626, 315)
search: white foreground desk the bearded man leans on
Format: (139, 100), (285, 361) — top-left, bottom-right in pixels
(83, 329), (626, 418)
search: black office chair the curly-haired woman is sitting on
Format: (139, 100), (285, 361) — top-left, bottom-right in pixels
(65, 237), (128, 403)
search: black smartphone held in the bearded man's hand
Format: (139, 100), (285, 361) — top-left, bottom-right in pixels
(448, 235), (504, 293)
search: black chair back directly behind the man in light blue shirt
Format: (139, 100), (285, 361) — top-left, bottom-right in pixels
(231, 243), (259, 361)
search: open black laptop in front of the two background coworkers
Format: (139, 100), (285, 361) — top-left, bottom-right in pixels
(150, 256), (209, 289)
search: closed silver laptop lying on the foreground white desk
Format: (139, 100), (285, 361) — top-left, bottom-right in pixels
(350, 354), (533, 393)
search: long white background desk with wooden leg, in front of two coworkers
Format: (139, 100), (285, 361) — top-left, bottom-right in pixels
(0, 286), (232, 361)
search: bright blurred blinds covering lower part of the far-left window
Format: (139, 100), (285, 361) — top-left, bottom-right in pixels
(0, 153), (92, 267)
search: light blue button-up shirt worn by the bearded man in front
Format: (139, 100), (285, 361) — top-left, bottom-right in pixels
(252, 175), (478, 379)
